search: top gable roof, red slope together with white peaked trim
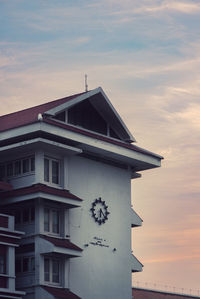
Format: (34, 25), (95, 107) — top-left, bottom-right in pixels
(0, 87), (135, 143)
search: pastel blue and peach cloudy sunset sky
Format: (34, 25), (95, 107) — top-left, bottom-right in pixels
(0, 0), (200, 295)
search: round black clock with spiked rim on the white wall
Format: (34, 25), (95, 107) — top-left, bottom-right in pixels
(90, 197), (110, 225)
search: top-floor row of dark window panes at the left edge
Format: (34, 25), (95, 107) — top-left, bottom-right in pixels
(0, 157), (35, 179)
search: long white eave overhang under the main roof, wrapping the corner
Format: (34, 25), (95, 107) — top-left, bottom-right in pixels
(0, 119), (163, 171)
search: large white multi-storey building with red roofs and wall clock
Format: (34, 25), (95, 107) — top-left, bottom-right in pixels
(0, 88), (162, 299)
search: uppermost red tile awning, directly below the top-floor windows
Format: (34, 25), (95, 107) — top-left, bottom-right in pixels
(1, 184), (82, 201)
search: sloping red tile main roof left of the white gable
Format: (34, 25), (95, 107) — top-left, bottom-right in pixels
(0, 93), (83, 132)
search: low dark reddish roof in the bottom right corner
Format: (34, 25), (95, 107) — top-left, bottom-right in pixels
(133, 288), (200, 299)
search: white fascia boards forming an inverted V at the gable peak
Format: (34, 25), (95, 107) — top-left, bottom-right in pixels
(45, 87), (136, 142)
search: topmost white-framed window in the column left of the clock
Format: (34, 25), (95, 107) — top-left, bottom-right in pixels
(44, 158), (60, 185)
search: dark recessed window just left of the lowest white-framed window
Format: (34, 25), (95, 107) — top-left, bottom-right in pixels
(15, 256), (35, 273)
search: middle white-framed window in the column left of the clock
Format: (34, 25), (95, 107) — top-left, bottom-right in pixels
(44, 208), (60, 234)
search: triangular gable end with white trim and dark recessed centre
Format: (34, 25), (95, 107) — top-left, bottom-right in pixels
(44, 87), (136, 143)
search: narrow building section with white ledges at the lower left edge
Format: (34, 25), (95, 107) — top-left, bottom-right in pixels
(0, 212), (24, 299)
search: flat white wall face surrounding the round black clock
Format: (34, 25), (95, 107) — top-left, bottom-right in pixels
(69, 157), (132, 299)
